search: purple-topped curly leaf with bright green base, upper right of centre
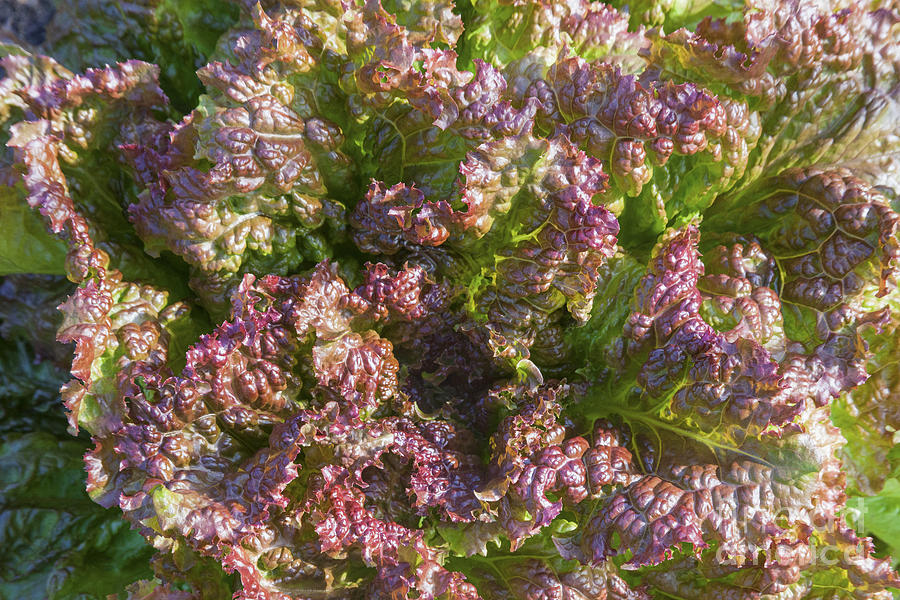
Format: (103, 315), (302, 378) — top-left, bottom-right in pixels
(506, 52), (759, 245)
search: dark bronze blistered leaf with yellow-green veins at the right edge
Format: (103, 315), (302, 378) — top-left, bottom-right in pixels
(704, 169), (900, 346)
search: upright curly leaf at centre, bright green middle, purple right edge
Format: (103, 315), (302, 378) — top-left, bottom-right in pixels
(351, 131), (618, 365)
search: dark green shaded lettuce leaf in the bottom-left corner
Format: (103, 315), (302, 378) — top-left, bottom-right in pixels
(0, 432), (152, 600)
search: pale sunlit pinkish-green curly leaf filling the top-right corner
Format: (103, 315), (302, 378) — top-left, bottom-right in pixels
(650, 2), (900, 189)
